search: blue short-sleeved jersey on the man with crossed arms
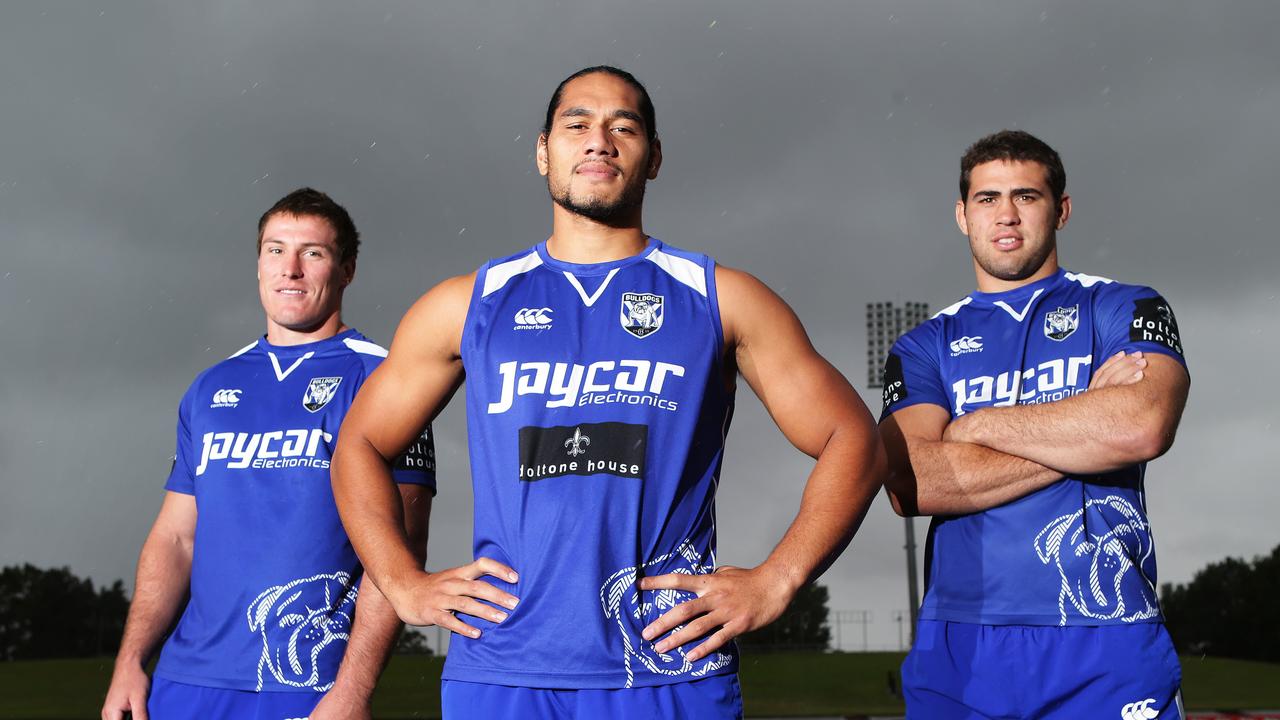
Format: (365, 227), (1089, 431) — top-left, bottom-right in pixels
(881, 270), (1185, 625)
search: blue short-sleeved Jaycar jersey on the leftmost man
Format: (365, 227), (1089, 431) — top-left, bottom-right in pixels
(156, 331), (435, 692)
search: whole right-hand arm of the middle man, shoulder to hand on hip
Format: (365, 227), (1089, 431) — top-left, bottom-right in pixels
(640, 268), (884, 662)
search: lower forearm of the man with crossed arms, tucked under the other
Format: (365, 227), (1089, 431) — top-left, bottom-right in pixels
(884, 439), (1062, 515)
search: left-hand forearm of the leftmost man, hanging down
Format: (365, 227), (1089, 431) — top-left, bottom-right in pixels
(116, 533), (191, 666)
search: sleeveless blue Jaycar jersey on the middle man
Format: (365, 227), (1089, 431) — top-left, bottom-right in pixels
(443, 238), (737, 688)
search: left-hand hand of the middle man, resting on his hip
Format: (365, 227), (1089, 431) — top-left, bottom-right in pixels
(394, 557), (520, 638)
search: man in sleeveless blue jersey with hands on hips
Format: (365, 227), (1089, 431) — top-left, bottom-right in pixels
(334, 67), (883, 719)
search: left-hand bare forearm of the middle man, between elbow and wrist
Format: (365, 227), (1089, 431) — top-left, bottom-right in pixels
(332, 434), (422, 596)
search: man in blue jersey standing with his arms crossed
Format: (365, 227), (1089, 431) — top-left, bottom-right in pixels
(881, 131), (1190, 720)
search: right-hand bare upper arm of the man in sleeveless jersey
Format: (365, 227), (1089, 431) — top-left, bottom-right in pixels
(716, 268), (876, 457)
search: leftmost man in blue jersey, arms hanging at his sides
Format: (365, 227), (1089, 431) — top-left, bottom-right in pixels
(102, 188), (435, 720)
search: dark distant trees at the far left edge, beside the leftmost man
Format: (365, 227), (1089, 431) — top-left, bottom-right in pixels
(0, 565), (129, 660)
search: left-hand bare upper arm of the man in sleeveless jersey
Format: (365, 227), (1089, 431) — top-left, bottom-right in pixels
(339, 277), (471, 460)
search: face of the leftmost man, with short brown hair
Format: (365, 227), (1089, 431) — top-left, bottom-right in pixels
(257, 214), (356, 337)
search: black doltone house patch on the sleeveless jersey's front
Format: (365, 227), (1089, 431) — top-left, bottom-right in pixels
(520, 423), (649, 482)
